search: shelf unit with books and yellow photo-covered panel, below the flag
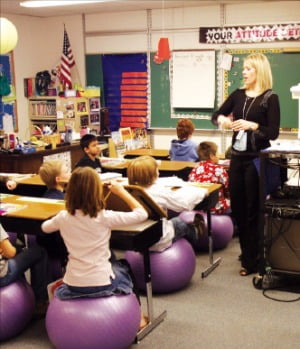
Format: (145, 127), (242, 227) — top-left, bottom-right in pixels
(29, 96), (100, 132)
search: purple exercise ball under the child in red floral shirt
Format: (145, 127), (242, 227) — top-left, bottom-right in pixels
(179, 211), (234, 251)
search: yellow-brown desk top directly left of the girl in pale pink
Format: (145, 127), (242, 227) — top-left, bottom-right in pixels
(1, 194), (65, 221)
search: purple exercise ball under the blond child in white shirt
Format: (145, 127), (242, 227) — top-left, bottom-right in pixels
(125, 238), (196, 293)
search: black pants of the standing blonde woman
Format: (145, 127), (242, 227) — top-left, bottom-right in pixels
(229, 155), (259, 271)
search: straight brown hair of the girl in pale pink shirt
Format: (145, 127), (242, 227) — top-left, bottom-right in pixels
(66, 167), (105, 217)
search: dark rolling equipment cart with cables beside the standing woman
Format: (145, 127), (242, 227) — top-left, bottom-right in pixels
(259, 149), (300, 275)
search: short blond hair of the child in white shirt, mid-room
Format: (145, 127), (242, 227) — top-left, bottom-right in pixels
(127, 155), (158, 187)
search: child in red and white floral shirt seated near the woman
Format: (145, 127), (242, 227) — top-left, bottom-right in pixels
(189, 142), (230, 214)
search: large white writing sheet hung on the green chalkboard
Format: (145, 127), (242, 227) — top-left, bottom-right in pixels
(172, 50), (215, 108)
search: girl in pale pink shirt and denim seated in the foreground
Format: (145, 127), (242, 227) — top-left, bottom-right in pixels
(42, 167), (147, 327)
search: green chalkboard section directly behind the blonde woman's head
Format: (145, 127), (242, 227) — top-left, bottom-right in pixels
(224, 49), (300, 129)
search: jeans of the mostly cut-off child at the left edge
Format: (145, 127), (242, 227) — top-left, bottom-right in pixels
(0, 246), (48, 301)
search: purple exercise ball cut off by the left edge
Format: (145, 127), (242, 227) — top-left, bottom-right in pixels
(0, 280), (35, 341)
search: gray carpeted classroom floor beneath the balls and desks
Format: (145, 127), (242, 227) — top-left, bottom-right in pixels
(0, 238), (300, 349)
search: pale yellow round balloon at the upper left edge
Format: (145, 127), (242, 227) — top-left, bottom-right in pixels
(0, 17), (18, 55)
